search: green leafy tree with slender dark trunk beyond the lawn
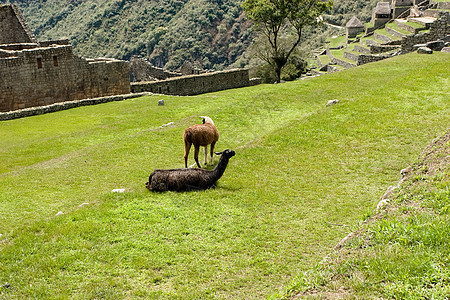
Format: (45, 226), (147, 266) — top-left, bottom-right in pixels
(242, 0), (333, 82)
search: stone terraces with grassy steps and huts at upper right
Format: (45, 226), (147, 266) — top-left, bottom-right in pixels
(313, 0), (450, 75)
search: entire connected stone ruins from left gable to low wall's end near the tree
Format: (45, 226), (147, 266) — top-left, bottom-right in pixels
(0, 4), (253, 116)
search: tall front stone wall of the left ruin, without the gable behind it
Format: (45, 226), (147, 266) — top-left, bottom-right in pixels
(0, 46), (130, 112)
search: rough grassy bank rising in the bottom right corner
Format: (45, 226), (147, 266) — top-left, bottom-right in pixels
(282, 131), (450, 299)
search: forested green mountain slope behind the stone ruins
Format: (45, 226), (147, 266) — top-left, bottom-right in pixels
(6, 0), (376, 70)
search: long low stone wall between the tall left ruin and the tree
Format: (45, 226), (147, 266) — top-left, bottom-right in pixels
(131, 69), (250, 96)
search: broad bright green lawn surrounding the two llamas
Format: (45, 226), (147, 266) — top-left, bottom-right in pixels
(0, 53), (450, 298)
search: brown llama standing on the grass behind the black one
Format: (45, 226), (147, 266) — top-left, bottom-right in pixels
(183, 116), (219, 168)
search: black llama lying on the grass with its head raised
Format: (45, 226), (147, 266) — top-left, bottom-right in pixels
(145, 149), (236, 192)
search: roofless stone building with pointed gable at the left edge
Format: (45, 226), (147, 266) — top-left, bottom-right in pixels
(0, 4), (130, 112)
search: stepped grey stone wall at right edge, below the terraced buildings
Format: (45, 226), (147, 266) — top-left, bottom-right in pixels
(402, 12), (450, 53)
